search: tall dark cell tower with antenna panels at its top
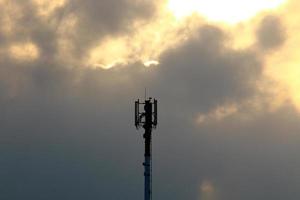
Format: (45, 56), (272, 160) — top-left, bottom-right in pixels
(135, 98), (157, 200)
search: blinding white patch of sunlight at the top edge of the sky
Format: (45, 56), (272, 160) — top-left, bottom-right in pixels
(168, 0), (286, 24)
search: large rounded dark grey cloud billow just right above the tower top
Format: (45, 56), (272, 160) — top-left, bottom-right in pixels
(158, 26), (262, 114)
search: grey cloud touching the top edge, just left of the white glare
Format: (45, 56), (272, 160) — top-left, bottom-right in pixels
(64, 0), (158, 57)
